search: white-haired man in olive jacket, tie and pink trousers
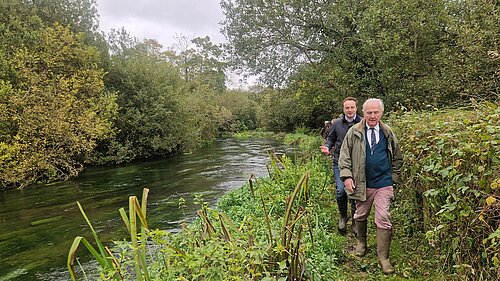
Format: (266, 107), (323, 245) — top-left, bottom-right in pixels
(339, 99), (403, 274)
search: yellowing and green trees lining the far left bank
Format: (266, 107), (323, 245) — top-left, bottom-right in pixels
(0, 0), (256, 189)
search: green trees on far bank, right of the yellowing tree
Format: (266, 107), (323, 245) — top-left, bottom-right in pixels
(95, 29), (255, 163)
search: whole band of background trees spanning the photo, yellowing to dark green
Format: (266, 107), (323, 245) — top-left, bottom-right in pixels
(0, 0), (500, 189)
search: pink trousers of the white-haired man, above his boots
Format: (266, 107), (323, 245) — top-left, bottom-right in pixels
(354, 186), (394, 229)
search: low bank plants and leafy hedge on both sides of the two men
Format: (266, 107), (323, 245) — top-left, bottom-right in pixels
(68, 102), (500, 280)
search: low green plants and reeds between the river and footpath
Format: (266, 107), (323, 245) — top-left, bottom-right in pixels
(68, 133), (345, 280)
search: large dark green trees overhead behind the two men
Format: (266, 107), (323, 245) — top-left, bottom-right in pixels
(225, 0), (500, 126)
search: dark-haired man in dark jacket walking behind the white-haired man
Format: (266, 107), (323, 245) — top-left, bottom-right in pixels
(321, 97), (361, 233)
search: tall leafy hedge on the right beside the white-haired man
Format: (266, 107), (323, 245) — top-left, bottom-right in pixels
(390, 102), (500, 280)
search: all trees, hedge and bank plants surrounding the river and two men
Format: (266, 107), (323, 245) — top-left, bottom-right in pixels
(0, 0), (500, 280)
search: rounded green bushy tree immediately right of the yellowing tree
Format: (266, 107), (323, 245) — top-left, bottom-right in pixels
(97, 30), (198, 163)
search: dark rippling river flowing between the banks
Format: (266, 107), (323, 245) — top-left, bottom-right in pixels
(0, 139), (285, 281)
